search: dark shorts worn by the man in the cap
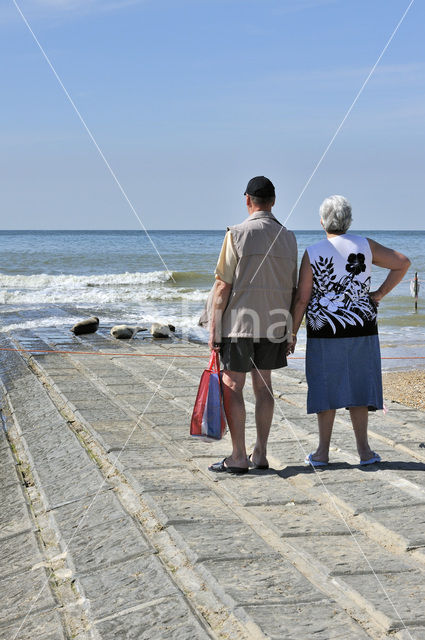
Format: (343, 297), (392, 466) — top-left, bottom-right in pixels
(220, 338), (288, 373)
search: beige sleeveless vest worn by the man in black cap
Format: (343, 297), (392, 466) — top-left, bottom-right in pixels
(221, 211), (297, 340)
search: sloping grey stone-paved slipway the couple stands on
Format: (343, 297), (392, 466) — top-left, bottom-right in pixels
(0, 322), (425, 640)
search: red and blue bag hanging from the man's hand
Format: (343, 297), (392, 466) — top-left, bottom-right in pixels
(190, 351), (227, 442)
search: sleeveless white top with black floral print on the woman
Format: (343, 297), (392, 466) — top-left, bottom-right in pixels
(306, 234), (378, 338)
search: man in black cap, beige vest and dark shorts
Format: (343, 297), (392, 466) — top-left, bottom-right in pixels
(209, 176), (297, 474)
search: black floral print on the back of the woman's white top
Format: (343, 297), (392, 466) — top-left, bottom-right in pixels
(307, 253), (376, 335)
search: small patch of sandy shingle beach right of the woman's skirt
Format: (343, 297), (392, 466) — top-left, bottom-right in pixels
(382, 370), (425, 411)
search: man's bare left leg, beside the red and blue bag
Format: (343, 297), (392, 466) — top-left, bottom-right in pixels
(223, 369), (247, 468)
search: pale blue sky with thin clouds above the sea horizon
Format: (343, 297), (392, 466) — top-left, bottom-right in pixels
(0, 0), (425, 229)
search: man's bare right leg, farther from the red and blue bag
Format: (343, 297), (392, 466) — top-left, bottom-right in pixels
(251, 369), (274, 465)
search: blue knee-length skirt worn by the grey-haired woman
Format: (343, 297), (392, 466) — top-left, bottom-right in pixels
(305, 335), (383, 413)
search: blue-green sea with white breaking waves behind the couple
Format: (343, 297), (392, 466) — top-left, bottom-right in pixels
(0, 230), (425, 369)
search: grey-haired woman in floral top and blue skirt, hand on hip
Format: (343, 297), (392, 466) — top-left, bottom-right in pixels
(288, 196), (410, 467)
